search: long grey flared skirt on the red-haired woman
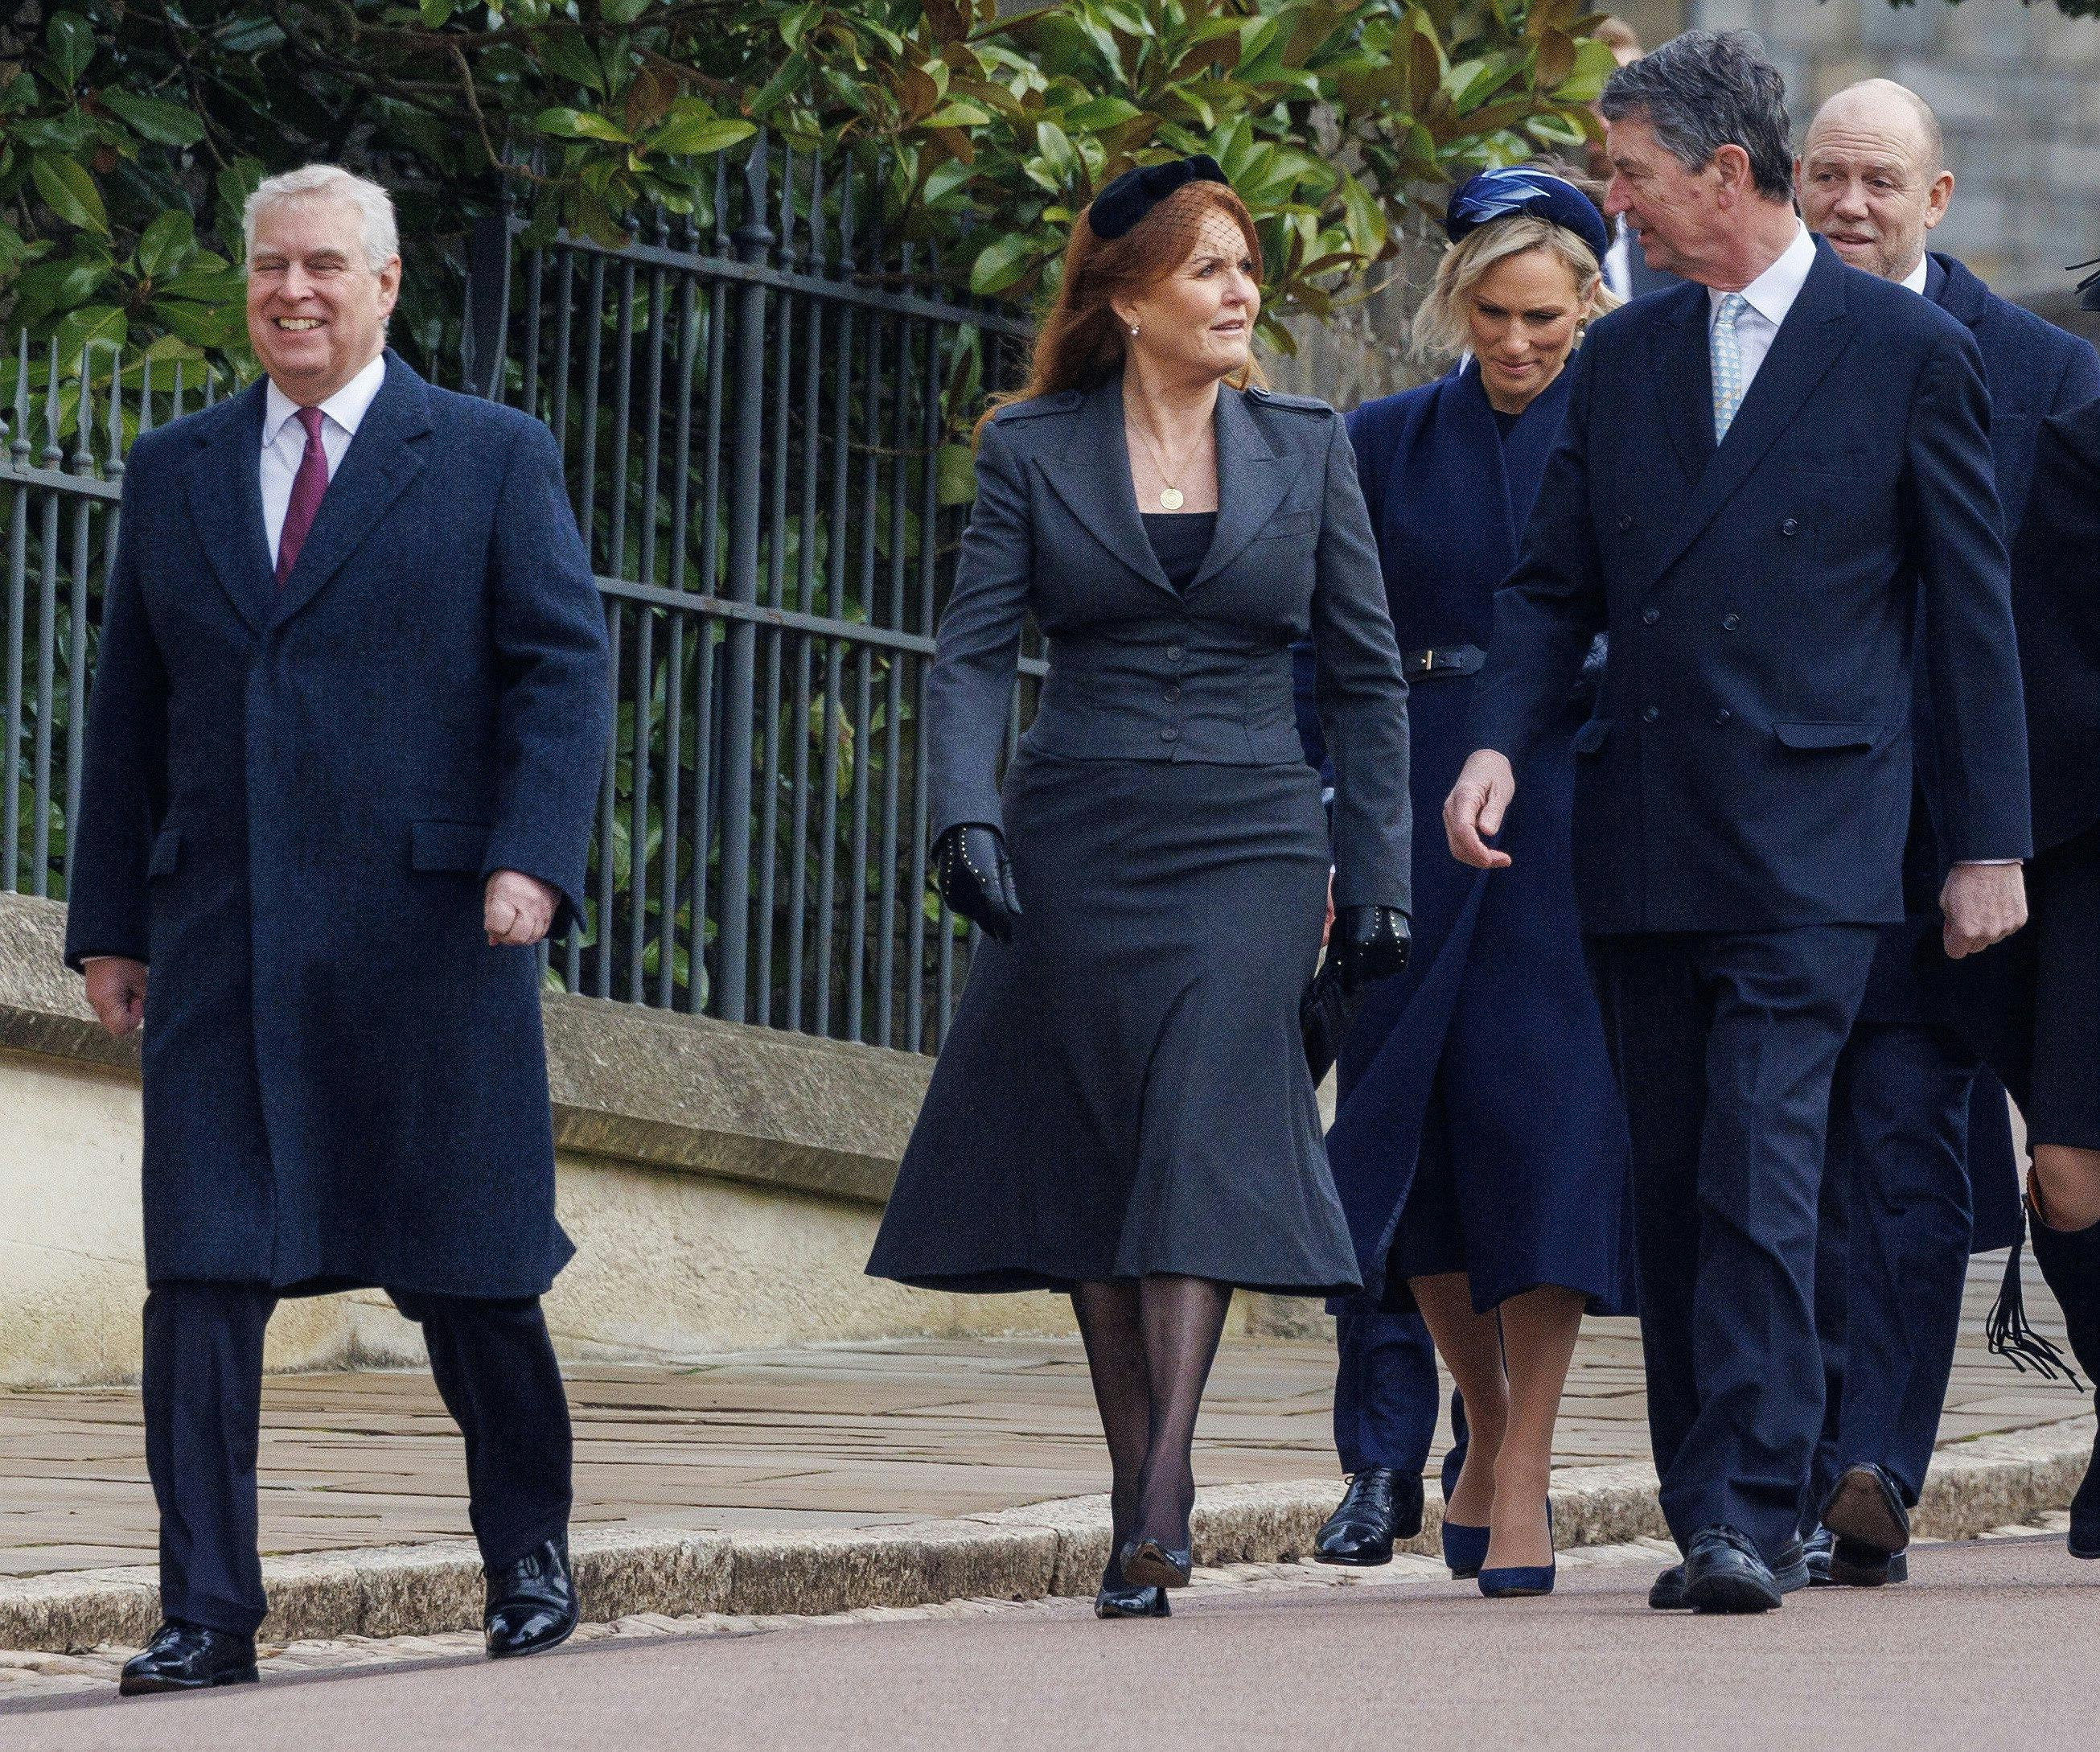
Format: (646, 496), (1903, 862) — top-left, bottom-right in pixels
(867, 750), (1358, 1296)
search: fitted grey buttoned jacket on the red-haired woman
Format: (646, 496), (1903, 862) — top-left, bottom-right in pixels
(926, 378), (1409, 910)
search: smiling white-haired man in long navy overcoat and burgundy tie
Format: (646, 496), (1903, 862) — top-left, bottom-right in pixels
(65, 166), (607, 1691)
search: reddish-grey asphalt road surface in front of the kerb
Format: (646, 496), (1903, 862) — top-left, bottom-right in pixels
(0, 1536), (2100, 1752)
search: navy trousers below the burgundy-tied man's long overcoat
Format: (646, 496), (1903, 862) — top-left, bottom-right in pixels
(141, 1281), (571, 1636)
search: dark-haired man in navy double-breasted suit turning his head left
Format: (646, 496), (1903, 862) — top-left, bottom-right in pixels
(1445, 31), (2028, 1611)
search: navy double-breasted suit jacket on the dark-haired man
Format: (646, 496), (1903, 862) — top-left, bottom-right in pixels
(1472, 240), (2028, 933)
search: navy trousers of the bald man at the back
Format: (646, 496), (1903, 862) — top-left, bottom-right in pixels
(1802, 1021), (1980, 1525)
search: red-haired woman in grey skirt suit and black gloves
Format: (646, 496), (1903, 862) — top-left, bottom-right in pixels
(867, 158), (1409, 1618)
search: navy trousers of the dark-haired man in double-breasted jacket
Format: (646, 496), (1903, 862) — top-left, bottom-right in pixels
(1585, 924), (1877, 1561)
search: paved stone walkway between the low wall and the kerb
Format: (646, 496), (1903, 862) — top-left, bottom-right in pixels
(0, 1256), (2090, 1576)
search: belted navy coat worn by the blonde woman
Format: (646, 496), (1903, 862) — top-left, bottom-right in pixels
(1300, 364), (1632, 1311)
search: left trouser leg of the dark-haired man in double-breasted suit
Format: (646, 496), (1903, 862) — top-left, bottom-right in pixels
(1585, 935), (1708, 1542)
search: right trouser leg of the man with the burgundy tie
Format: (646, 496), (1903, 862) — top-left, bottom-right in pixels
(386, 1289), (571, 1569)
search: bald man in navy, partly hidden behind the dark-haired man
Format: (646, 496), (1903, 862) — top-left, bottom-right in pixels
(1795, 80), (2100, 1586)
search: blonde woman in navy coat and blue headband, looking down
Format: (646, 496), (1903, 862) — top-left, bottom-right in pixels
(1301, 166), (1632, 1594)
